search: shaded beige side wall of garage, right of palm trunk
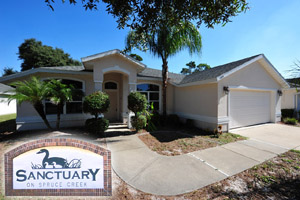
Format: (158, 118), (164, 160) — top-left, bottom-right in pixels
(173, 83), (218, 130)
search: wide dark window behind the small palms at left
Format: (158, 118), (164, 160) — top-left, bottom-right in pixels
(45, 79), (83, 115)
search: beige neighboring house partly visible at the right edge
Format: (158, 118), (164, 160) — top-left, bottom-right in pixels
(281, 78), (300, 113)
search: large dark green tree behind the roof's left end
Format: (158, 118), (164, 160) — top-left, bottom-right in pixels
(18, 38), (81, 71)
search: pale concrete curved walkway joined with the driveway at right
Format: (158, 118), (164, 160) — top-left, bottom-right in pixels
(106, 124), (300, 195)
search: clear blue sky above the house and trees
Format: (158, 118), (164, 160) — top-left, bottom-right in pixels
(0, 0), (300, 77)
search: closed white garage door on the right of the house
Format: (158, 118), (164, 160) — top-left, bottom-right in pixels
(230, 90), (271, 128)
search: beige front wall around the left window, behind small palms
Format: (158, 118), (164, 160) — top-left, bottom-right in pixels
(10, 73), (94, 130)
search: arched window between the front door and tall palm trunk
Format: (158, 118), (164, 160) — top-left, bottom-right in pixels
(137, 84), (160, 110)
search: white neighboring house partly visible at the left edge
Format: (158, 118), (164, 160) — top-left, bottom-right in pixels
(0, 83), (17, 115)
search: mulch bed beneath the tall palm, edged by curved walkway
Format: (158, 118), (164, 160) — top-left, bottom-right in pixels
(139, 130), (246, 156)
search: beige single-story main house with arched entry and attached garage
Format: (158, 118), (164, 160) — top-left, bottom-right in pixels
(0, 50), (289, 131)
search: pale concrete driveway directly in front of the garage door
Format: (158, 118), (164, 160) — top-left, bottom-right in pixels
(230, 124), (300, 149)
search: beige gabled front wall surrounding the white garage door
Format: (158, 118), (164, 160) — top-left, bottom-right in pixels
(218, 61), (281, 131)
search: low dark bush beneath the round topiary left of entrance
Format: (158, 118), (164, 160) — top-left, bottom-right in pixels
(85, 118), (109, 136)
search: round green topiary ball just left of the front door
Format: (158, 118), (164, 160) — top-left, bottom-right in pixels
(83, 91), (110, 119)
